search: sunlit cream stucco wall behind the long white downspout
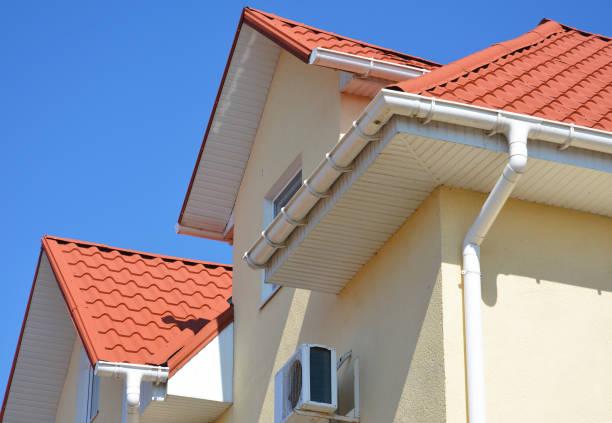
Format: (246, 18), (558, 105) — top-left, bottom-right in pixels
(440, 188), (612, 423)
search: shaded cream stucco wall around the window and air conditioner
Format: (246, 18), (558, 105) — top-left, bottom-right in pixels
(227, 52), (444, 423)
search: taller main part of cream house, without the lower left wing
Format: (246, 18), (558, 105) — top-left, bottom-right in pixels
(177, 8), (612, 423)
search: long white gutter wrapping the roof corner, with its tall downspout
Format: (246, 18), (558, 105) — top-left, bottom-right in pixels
(244, 90), (612, 423)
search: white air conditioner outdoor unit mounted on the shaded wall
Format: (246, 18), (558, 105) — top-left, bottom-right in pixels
(274, 344), (338, 423)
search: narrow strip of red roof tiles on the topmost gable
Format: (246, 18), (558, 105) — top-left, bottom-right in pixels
(243, 7), (440, 69)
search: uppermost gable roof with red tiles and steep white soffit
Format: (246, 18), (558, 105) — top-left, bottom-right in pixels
(177, 7), (440, 243)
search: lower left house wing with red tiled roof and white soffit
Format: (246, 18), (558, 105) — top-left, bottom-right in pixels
(0, 236), (234, 423)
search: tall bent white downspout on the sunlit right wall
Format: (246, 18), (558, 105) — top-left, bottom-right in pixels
(461, 121), (530, 423)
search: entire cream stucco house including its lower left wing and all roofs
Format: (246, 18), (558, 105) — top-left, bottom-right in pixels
(0, 8), (612, 423)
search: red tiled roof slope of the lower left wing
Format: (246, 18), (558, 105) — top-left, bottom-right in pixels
(42, 236), (233, 375)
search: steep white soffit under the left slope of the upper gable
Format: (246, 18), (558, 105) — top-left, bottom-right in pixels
(179, 24), (280, 238)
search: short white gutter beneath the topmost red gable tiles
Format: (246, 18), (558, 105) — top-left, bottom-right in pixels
(309, 47), (429, 82)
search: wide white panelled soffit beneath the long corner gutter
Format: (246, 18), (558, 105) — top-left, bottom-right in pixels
(265, 117), (612, 293)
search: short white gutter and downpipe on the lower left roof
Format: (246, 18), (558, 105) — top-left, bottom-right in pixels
(94, 361), (169, 423)
